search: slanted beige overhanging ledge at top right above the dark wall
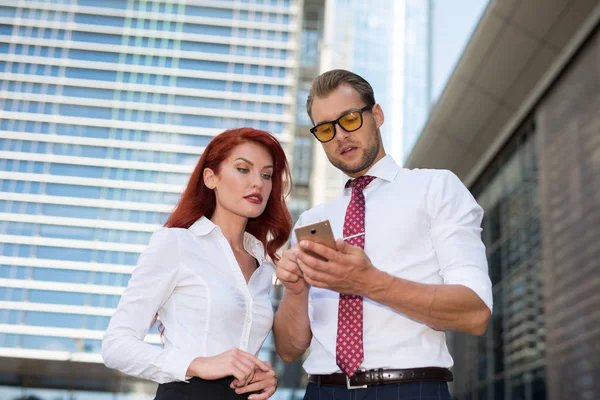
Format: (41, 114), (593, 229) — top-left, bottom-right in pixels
(405, 0), (600, 186)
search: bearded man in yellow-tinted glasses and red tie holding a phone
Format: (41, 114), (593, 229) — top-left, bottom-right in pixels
(274, 70), (492, 400)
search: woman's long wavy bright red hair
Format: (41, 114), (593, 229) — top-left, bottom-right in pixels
(165, 128), (292, 261)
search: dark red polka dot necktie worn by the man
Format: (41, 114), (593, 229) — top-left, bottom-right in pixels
(335, 175), (375, 376)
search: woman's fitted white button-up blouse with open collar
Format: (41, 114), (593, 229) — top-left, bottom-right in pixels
(102, 217), (274, 383)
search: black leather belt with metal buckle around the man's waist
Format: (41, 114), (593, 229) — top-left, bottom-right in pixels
(308, 367), (454, 389)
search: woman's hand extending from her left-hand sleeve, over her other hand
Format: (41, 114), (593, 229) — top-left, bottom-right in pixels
(186, 348), (272, 386)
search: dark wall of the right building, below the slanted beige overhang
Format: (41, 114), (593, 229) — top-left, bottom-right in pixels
(449, 22), (600, 400)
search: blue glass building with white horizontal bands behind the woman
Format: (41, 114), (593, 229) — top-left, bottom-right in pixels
(0, 0), (300, 399)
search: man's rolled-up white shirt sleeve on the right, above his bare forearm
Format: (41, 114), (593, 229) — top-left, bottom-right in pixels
(428, 170), (493, 311)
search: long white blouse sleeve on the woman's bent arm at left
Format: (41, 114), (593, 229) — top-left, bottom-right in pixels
(102, 228), (195, 383)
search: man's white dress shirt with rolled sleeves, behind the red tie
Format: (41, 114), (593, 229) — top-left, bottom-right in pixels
(294, 156), (492, 374)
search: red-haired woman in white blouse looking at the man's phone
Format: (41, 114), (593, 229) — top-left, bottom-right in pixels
(102, 128), (292, 400)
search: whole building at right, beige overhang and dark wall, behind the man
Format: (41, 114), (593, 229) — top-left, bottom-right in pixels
(407, 0), (600, 400)
